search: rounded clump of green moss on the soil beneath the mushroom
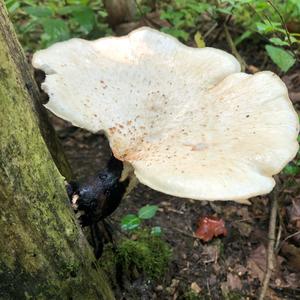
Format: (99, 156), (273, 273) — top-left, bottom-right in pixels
(117, 230), (171, 279)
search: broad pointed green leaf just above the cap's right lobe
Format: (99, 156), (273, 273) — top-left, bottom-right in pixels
(266, 45), (296, 72)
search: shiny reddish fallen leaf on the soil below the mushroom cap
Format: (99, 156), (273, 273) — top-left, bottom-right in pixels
(195, 216), (227, 242)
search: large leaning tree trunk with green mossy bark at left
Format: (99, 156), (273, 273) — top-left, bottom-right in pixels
(0, 0), (114, 300)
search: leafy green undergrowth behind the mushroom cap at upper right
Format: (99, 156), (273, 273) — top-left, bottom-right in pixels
(160, 0), (300, 72)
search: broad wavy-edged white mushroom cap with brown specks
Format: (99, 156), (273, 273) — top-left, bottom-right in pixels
(33, 28), (299, 203)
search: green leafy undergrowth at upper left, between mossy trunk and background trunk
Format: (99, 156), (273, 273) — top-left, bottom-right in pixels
(5, 0), (111, 51)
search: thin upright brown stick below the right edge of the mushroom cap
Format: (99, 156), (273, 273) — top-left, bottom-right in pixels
(258, 189), (278, 300)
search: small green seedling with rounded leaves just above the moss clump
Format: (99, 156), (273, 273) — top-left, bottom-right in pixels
(121, 204), (161, 236)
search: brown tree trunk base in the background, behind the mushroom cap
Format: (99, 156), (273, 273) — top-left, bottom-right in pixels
(103, 0), (136, 28)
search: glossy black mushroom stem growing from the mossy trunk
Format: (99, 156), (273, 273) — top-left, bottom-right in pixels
(67, 155), (131, 258)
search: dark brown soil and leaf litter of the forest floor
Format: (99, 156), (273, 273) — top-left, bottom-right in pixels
(47, 24), (300, 300)
